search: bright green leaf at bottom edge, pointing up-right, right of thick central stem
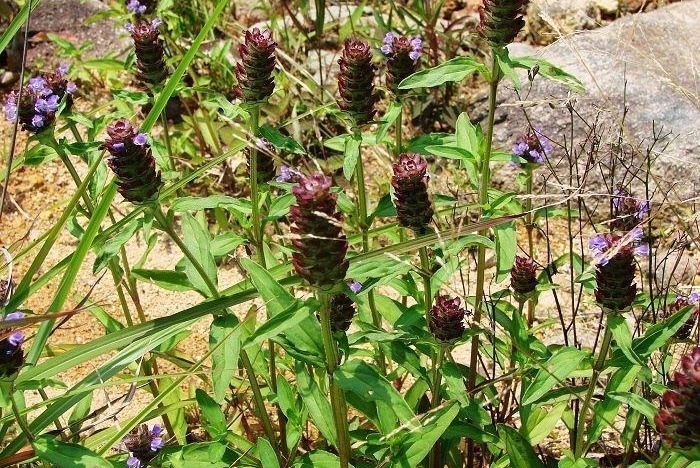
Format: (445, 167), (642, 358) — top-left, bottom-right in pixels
(390, 401), (459, 468)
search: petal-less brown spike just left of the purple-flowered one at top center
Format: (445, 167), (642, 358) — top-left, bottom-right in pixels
(338, 38), (379, 125)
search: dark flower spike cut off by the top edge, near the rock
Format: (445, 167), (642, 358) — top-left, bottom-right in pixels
(477, 0), (529, 48)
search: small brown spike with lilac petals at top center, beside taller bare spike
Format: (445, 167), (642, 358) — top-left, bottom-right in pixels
(380, 32), (423, 95)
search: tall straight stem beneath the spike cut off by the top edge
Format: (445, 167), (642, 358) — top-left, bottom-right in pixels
(467, 51), (500, 468)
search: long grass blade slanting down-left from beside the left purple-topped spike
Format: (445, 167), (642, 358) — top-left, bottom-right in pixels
(27, 185), (117, 365)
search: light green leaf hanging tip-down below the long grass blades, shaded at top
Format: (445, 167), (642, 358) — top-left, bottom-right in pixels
(209, 315), (243, 404)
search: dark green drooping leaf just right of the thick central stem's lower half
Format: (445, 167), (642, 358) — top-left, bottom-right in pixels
(334, 360), (415, 423)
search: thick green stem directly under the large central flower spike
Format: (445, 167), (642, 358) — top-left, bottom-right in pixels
(317, 290), (350, 468)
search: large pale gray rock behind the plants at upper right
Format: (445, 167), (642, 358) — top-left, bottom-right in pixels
(478, 0), (700, 201)
